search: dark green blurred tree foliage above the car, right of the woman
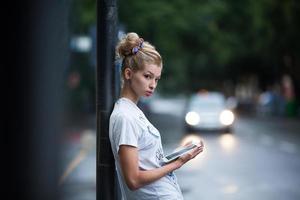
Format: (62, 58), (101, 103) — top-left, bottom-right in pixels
(119, 0), (300, 92)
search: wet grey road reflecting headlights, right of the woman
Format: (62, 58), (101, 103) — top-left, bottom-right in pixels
(149, 96), (300, 200)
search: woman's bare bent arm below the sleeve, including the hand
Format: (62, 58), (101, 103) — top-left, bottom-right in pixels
(119, 145), (203, 190)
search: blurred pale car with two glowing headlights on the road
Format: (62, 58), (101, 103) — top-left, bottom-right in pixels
(185, 91), (235, 133)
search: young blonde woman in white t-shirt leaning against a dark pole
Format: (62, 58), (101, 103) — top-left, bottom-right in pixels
(109, 33), (203, 200)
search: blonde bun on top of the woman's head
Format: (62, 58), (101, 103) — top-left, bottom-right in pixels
(116, 33), (143, 58)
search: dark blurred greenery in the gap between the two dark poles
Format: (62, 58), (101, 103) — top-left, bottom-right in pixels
(65, 0), (97, 115)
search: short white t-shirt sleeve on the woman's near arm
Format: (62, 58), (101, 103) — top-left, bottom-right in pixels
(113, 115), (139, 152)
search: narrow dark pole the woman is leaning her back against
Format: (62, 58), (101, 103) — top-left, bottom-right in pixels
(96, 0), (117, 200)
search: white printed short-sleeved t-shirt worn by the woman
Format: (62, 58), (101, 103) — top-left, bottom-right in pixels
(109, 97), (183, 200)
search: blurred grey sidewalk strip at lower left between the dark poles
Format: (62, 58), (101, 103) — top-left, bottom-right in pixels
(59, 116), (96, 200)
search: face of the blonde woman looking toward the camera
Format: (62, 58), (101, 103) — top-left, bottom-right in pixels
(130, 64), (162, 97)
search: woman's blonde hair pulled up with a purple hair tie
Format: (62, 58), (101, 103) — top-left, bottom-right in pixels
(116, 33), (162, 78)
